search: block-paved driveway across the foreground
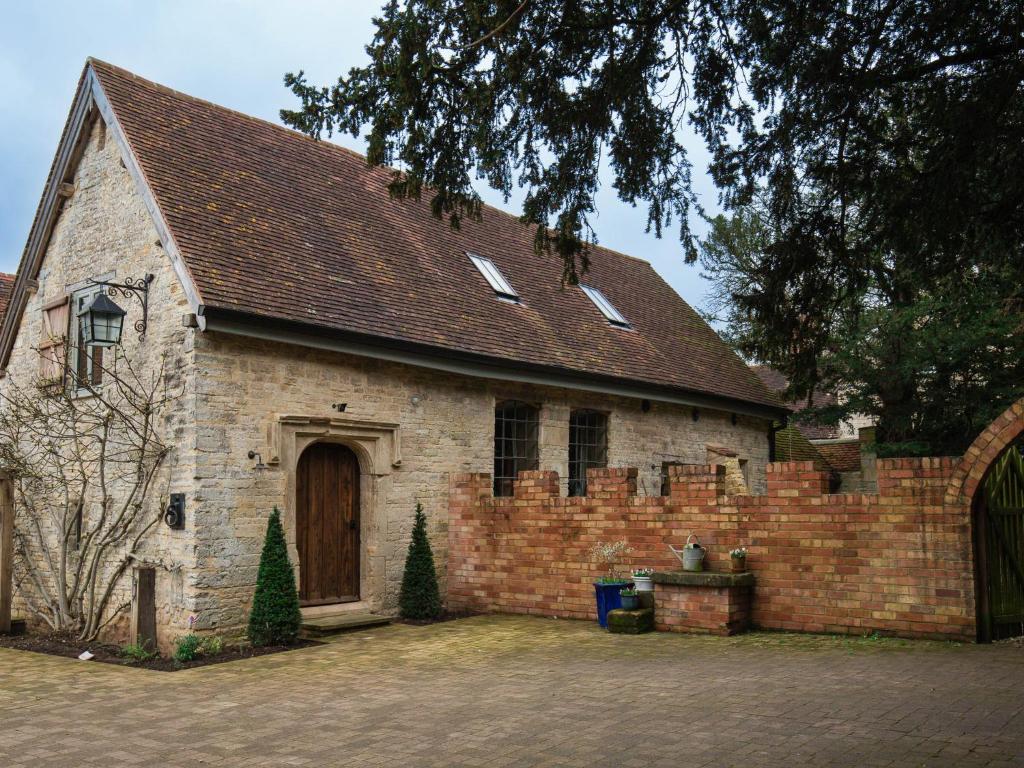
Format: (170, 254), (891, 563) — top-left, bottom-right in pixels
(0, 616), (1024, 768)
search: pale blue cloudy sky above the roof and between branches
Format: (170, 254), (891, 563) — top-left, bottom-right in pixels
(0, 0), (715, 313)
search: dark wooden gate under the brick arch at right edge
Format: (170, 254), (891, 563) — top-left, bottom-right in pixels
(975, 440), (1024, 642)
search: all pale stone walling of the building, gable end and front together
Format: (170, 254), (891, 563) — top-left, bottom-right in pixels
(2, 111), (768, 650)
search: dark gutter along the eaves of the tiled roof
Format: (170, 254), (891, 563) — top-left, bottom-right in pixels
(197, 305), (788, 421)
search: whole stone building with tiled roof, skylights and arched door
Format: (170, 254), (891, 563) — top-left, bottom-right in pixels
(0, 59), (783, 646)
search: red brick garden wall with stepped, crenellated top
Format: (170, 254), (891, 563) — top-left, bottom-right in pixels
(447, 459), (975, 639)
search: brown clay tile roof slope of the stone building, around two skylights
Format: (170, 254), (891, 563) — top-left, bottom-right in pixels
(89, 60), (779, 409)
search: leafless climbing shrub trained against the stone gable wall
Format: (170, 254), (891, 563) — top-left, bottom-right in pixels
(0, 351), (173, 641)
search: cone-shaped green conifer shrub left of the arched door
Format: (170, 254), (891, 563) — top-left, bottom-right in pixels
(248, 507), (302, 645)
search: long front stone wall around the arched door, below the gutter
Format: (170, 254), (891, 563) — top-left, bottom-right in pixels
(188, 333), (768, 629)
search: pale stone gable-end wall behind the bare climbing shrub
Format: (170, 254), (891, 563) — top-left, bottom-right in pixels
(0, 120), (196, 648)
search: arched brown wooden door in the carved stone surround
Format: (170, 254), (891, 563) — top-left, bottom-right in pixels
(295, 442), (359, 605)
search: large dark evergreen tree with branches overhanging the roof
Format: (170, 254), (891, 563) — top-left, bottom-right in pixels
(282, 0), (1024, 448)
